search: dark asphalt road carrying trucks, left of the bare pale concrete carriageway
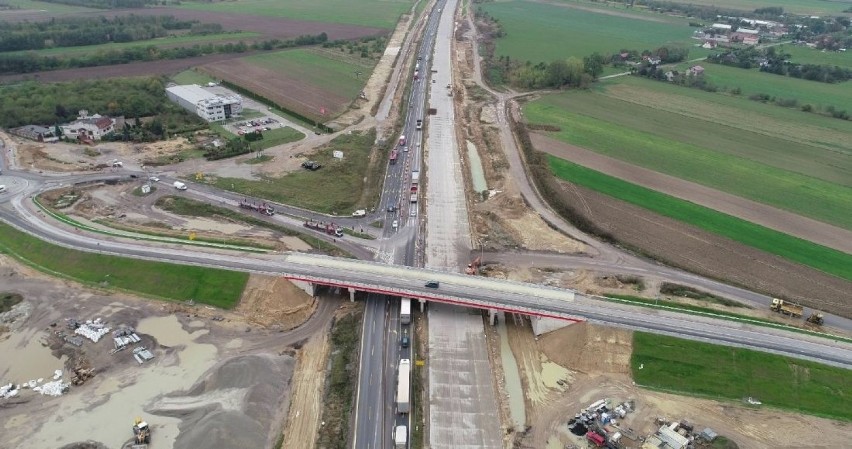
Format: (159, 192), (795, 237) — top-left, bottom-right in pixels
(353, 0), (450, 449)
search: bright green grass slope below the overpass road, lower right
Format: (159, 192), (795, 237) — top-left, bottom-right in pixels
(630, 332), (852, 421)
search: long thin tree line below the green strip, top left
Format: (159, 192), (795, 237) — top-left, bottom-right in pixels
(0, 33), (328, 75)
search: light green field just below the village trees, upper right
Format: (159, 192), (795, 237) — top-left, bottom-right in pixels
(679, 63), (852, 113)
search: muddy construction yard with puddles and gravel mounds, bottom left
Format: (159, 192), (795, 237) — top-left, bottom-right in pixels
(0, 252), (341, 449)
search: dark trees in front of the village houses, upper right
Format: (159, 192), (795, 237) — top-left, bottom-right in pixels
(707, 47), (852, 83)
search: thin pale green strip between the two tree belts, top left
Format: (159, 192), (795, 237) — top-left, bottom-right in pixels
(4, 32), (260, 57)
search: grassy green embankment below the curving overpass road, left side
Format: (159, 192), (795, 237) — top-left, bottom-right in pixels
(0, 223), (248, 308)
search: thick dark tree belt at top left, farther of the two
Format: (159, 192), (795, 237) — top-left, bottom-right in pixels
(0, 15), (198, 52)
